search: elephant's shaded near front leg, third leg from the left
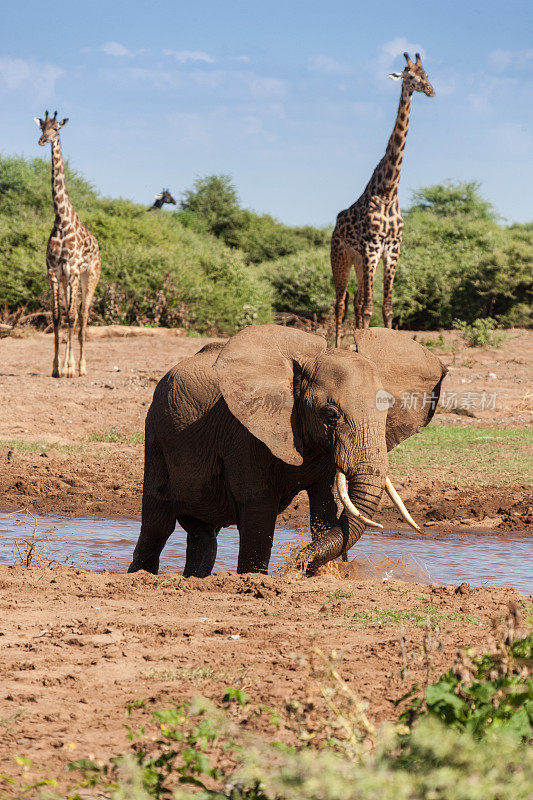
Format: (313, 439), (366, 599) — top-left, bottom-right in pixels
(237, 500), (278, 574)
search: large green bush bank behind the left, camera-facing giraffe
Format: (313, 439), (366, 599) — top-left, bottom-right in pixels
(0, 158), (271, 333)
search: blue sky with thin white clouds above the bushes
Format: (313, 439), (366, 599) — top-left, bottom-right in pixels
(0, 0), (533, 224)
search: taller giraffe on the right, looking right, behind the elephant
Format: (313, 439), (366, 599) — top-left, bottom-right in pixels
(331, 53), (435, 347)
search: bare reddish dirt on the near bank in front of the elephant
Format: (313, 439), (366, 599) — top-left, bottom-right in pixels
(0, 567), (533, 796)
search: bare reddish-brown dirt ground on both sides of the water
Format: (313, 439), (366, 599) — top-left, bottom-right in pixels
(0, 328), (533, 796)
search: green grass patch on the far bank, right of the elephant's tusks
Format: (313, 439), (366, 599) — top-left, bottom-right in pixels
(390, 425), (533, 486)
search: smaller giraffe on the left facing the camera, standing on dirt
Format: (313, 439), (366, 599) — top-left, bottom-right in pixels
(34, 111), (101, 378)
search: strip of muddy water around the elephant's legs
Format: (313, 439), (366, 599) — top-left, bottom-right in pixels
(0, 513), (533, 594)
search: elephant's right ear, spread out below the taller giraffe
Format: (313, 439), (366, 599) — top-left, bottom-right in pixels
(354, 328), (448, 450)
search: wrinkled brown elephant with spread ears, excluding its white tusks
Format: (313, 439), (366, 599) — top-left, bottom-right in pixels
(129, 325), (445, 577)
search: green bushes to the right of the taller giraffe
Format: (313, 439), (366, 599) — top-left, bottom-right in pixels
(394, 184), (533, 330)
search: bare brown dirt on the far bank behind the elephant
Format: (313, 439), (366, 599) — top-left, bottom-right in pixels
(0, 326), (533, 530)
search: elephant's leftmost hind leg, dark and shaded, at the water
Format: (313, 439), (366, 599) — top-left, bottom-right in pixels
(128, 494), (176, 575)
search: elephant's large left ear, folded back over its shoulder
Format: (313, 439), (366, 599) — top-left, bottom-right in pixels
(214, 325), (326, 466)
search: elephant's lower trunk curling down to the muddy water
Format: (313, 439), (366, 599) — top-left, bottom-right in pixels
(296, 457), (386, 576)
